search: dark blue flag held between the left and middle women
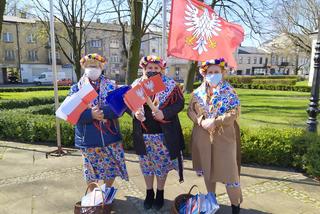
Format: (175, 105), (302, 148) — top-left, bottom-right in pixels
(106, 86), (131, 117)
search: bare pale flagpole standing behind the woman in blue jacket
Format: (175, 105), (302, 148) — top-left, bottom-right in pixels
(46, 0), (64, 157)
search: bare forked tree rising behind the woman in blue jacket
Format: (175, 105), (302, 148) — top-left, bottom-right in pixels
(33, 0), (101, 79)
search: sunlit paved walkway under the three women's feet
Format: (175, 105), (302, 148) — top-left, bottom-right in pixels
(0, 141), (320, 214)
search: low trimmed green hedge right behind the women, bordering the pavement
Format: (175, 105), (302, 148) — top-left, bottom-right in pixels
(0, 104), (320, 177)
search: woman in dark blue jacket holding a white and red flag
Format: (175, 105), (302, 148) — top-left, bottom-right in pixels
(70, 54), (128, 186)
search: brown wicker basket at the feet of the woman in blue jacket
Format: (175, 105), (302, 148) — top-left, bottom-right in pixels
(74, 182), (111, 214)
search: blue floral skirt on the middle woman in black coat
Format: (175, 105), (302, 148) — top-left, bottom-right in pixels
(139, 134), (179, 178)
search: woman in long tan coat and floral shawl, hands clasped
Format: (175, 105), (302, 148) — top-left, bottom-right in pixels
(188, 58), (242, 214)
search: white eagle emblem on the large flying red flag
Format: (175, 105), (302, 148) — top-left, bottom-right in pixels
(185, 0), (221, 54)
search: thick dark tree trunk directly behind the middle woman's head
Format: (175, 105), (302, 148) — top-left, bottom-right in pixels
(126, 0), (143, 84)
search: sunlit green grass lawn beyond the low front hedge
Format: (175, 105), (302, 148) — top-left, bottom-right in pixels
(0, 89), (310, 127)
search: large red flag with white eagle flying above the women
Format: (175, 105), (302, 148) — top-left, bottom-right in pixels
(168, 0), (244, 67)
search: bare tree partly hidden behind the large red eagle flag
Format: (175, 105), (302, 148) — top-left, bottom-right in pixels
(184, 0), (272, 93)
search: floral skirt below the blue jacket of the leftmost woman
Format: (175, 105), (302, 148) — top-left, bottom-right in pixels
(81, 142), (129, 182)
